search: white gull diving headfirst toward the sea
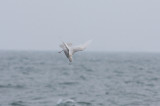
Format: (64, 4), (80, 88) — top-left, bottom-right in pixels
(59, 40), (91, 62)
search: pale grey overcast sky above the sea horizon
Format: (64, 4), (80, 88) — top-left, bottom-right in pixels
(0, 0), (160, 52)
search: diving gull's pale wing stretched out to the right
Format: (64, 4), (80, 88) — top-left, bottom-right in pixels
(72, 40), (92, 53)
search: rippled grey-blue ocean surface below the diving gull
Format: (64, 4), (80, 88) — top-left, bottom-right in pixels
(0, 51), (160, 106)
